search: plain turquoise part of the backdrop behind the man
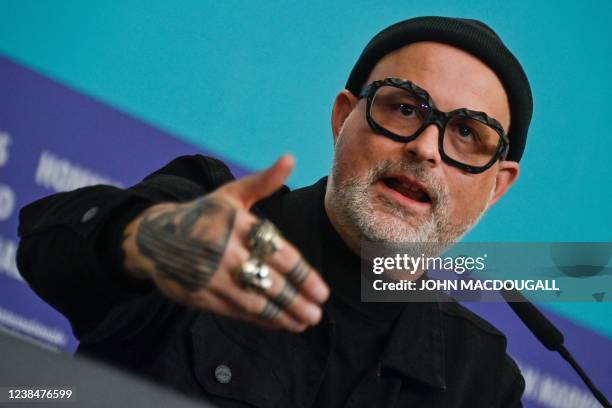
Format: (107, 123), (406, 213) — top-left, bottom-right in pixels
(0, 0), (612, 338)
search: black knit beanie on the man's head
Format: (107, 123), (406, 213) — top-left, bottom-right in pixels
(346, 17), (533, 161)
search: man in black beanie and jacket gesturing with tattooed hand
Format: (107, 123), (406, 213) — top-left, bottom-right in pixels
(18, 17), (532, 407)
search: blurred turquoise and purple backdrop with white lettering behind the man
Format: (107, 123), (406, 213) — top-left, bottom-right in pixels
(0, 0), (612, 407)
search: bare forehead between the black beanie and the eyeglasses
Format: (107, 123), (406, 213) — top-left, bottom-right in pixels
(367, 42), (510, 131)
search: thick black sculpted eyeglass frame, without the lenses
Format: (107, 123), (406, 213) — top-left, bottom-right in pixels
(359, 78), (510, 174)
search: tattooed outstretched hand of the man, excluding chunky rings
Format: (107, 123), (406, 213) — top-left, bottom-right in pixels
(123, 156), (329, 331)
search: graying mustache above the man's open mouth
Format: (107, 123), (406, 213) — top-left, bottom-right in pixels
(369, 160), (449, 204)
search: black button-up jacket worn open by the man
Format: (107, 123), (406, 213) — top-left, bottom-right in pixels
(17, 155), (524, 408)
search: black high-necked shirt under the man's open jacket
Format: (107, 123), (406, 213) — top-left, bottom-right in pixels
(315, 186), (405, 407)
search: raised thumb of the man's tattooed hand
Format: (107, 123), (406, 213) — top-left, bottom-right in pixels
(224, 154), (295, 208)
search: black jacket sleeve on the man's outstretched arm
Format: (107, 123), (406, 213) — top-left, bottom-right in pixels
(17, 155), (233, 341)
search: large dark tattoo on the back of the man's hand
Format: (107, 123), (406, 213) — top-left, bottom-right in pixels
(136, 197), (236, 292)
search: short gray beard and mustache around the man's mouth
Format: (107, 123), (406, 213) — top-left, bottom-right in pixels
(329, 150), (494, 243)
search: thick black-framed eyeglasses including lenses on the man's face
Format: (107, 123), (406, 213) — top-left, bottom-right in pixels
(359, 78), (509, 174)
